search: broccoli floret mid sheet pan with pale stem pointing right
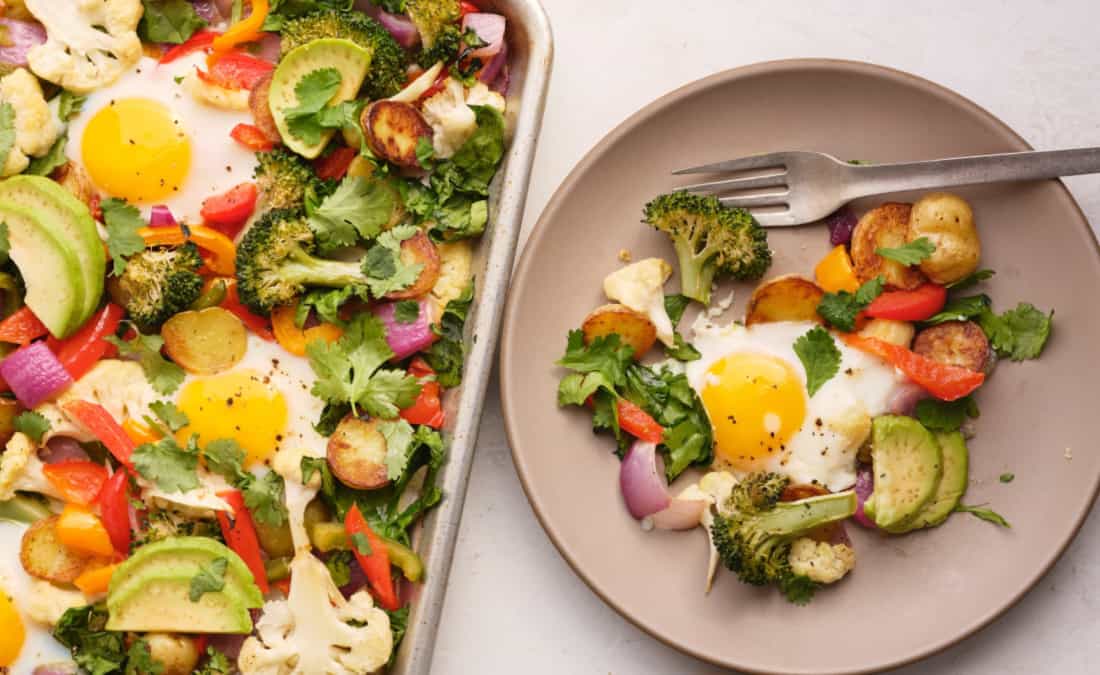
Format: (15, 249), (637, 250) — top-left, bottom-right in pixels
(237, 209), (366, 314)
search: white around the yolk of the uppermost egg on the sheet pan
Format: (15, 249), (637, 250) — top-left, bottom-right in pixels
(65, 53), (256, 223)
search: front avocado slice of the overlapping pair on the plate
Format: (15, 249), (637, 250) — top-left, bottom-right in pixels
(864, 414), (944, 533)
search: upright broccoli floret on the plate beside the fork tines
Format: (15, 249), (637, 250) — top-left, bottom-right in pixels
(645, 191), (771, 305)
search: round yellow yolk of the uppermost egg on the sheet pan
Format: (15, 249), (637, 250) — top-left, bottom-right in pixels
(80, 99), (191, 203)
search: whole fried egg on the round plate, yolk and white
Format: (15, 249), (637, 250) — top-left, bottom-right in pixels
(685, 317), (906, 490)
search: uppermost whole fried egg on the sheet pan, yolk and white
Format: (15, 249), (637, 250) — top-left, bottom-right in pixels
(66, 53), (256, 222)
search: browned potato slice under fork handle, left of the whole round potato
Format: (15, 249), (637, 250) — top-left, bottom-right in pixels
(851, 202), (925, 290)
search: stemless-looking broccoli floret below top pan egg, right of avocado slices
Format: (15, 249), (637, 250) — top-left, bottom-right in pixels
(113, 242), (202, 333)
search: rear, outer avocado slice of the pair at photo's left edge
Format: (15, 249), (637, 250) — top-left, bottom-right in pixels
(0, 176), (107, 327)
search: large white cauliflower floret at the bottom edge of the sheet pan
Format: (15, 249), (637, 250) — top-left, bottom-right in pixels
(238, 551), (394, 675)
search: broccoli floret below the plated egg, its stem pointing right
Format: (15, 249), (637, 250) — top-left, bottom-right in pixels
(711, 473), (856, 605)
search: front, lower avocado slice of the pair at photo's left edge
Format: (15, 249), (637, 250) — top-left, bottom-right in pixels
(0, 199), (84, 338)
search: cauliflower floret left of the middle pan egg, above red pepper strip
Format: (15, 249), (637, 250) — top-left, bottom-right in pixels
(34, 358), (157, 442)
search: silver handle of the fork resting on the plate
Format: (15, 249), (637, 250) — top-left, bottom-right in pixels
(848, 147), (1100, 199)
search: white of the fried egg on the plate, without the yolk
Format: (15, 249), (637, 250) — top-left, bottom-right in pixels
(685, 314), (908, 491)
